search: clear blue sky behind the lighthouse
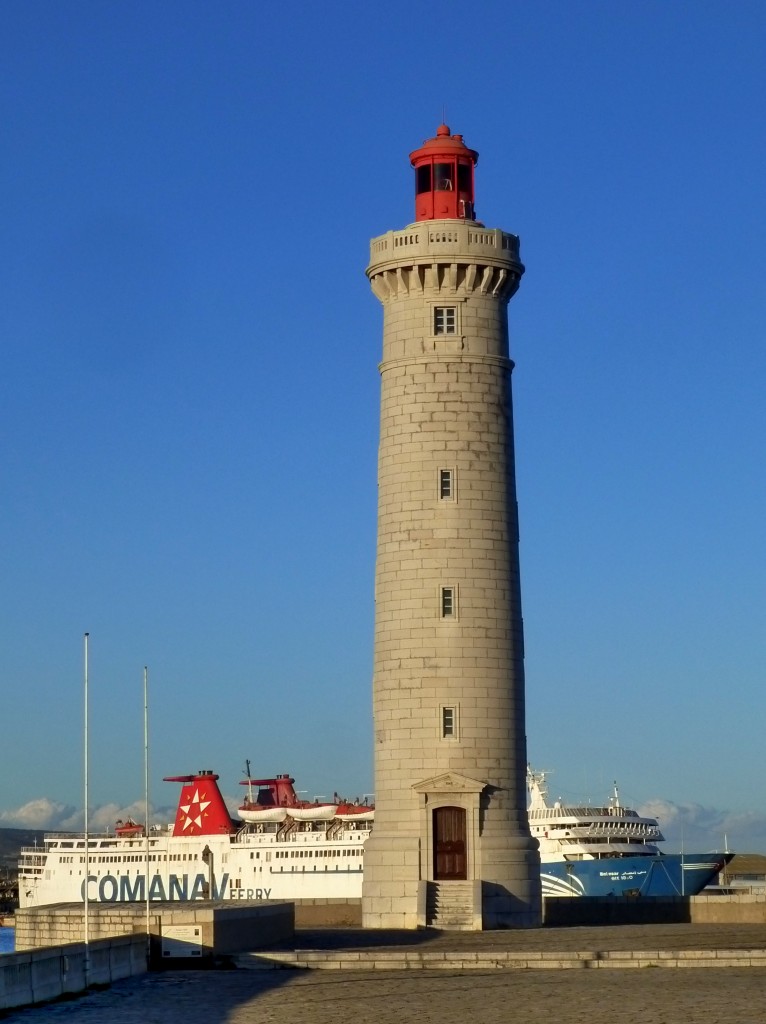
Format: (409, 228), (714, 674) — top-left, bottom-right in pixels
(0, 0), (766, 852)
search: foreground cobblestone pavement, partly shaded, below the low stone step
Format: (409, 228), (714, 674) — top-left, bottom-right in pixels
(4, 968), (766, 1024)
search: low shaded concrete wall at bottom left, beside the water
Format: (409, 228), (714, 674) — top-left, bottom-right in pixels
(0, 935), (146, 1010)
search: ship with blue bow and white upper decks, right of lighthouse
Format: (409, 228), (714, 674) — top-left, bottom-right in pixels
(526, 768), (732, 896)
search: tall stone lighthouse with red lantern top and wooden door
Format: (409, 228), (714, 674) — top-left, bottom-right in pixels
(363, 125), (541, 929)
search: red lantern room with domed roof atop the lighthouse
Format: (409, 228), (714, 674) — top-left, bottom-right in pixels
(410, 125), (478, 220)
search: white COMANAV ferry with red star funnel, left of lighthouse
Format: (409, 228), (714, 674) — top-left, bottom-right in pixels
(18, 771), (375, 907)
